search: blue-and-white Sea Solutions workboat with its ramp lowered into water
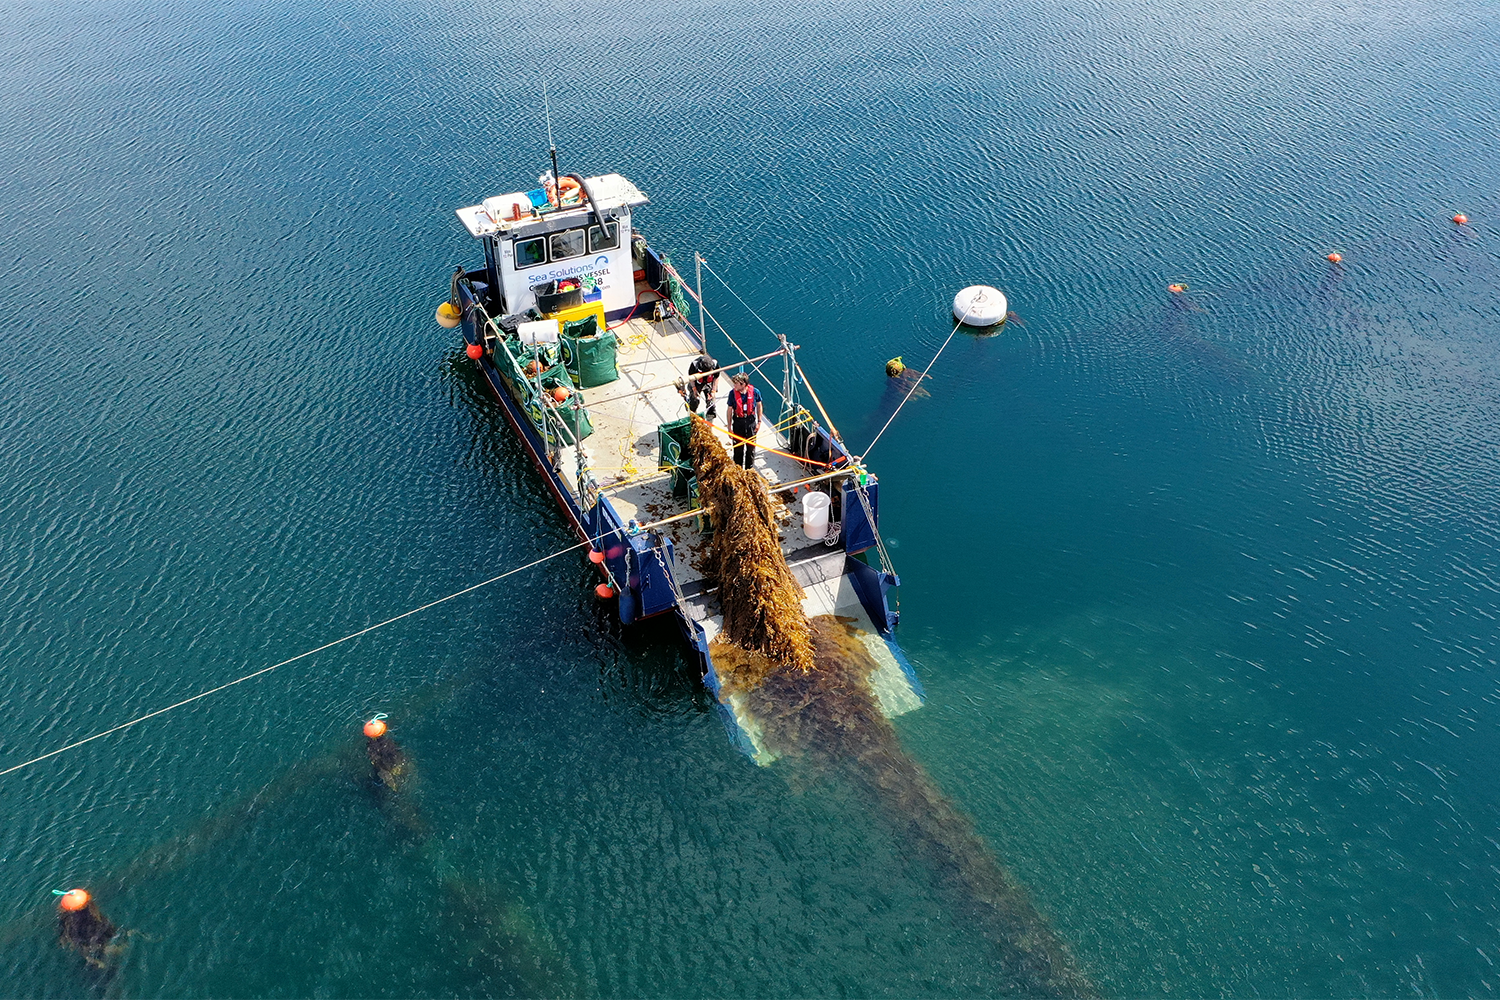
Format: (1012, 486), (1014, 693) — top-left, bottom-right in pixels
(438, 169), (923, 765)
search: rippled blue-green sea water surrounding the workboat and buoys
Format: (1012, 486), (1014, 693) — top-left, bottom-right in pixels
(0, 0), (1500, 999)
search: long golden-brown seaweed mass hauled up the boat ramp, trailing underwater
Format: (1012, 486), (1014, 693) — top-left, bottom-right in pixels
(690, 418), (1098, 1000)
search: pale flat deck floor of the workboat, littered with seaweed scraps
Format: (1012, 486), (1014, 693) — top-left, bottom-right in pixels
(560, 318), (822, 594)
